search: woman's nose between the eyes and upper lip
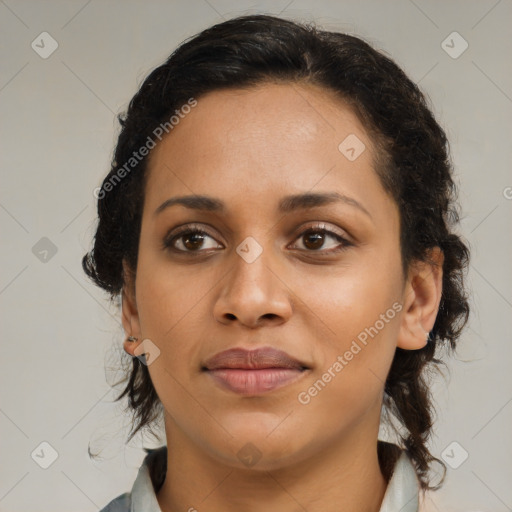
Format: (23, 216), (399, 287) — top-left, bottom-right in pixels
(213, 243), (293, 329)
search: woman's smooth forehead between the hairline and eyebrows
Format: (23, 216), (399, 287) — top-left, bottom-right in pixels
(142, 84), (390, 219)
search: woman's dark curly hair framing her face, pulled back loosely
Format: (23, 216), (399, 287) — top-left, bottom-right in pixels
(82, 15), (469, 490)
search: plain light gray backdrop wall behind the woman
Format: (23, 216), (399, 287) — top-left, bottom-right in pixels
(0, 0), (512, 512)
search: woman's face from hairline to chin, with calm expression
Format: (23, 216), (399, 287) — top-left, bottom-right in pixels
(123, 84), (414, 468)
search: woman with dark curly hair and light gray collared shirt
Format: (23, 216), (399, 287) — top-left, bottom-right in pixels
(83, 15), (469, 512)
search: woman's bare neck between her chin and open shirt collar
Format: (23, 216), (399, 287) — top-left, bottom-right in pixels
(157, 420), (387, 512)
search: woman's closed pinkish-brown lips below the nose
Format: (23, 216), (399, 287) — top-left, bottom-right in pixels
(201, 347), (310, 396)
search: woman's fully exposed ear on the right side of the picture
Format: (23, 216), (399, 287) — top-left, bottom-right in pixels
(397, 247), (444, 350)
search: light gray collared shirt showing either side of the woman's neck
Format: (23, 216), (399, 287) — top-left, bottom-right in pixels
(100, 446), (420, 512)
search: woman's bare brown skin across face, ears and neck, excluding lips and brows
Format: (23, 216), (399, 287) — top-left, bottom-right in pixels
(122, 84), (442, 512)
